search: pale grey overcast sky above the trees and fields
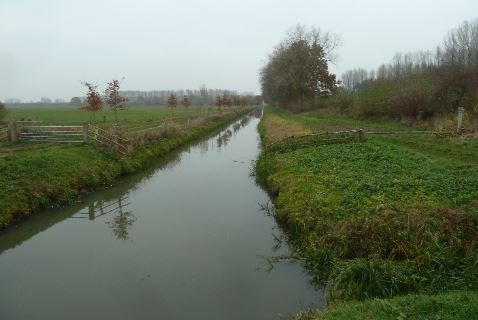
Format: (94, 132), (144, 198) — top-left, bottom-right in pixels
(0, 0), (478, 101)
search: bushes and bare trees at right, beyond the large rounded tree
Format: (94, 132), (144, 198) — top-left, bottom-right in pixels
(336, 19), (478, 120)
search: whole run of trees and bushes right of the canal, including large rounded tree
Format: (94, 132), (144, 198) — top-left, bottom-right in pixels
(260, 19), (478, 120)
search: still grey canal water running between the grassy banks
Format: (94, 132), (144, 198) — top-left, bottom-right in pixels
(0, 111), (325, 320)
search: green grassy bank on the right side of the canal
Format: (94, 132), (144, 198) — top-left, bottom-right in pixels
(257, 108), (478, 319)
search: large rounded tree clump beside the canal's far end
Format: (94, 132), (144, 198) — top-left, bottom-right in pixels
(260, 26), (339, 110)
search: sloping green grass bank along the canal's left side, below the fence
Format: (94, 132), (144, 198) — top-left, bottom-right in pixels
(0, 109), (246, 229)
